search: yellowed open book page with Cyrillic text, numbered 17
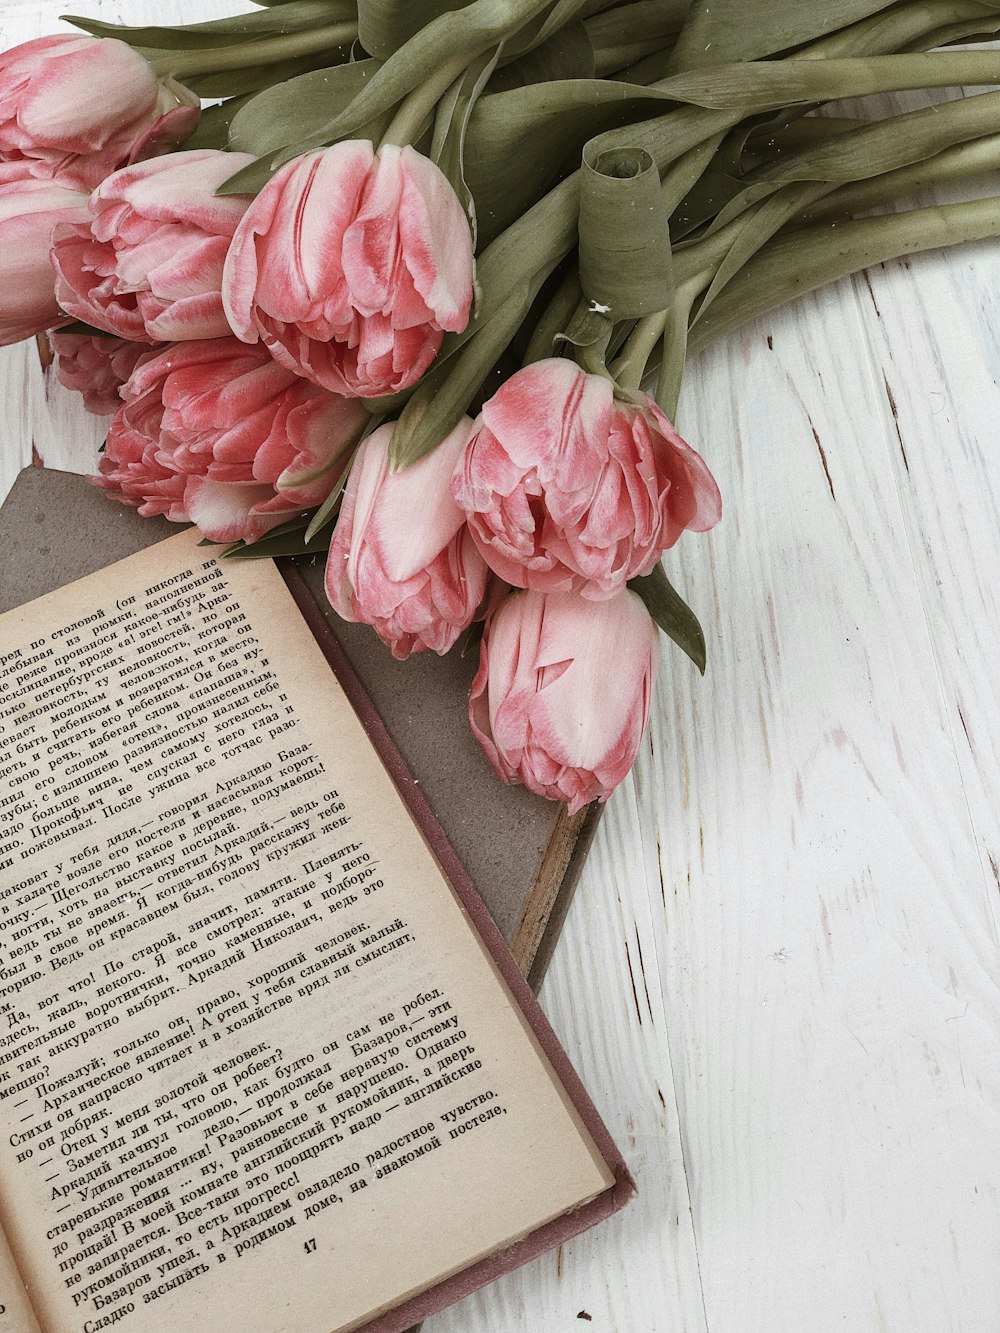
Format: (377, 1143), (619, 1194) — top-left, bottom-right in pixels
(0, 532), (612, 1333)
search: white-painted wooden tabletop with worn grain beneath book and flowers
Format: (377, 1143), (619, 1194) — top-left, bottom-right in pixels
(0, 0), (1000, 1333)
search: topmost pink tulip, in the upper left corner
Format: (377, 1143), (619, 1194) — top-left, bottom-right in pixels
(0, 33), (201, 189)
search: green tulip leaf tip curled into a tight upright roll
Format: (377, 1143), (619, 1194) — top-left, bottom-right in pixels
(580, 145), (673, 321)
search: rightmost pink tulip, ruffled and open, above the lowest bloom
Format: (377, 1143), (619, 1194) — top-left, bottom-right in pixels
(452, 359), (721, 600)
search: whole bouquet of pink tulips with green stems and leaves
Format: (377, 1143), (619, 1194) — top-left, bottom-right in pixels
(0, 0), (1000, 810)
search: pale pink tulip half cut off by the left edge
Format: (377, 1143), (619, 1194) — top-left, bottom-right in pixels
(0, 164), (88, 347)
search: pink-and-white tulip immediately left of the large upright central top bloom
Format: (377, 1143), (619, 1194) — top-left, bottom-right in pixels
(52, 148), (253, 343)
